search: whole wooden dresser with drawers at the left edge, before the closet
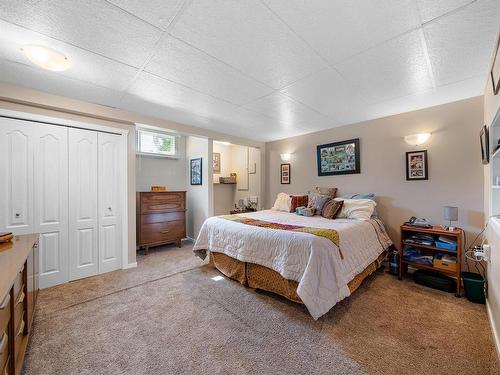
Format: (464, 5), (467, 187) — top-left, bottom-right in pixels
(0, 234), (39, 375)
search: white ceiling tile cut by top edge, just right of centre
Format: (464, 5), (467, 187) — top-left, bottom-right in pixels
(264, 0), (420, 63)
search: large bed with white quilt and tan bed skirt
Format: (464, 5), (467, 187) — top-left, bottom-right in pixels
(193, 210), (392, 319)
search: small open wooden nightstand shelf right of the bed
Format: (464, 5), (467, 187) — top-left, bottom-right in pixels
(399, 225), (463, 297)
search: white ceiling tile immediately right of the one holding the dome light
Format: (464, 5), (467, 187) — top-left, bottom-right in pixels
(128, 72), (241, 118)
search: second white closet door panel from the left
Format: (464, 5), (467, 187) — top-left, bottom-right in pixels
(34, 124), (69, 288)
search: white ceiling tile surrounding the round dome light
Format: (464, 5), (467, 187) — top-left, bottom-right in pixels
(0, 20), (138, 91)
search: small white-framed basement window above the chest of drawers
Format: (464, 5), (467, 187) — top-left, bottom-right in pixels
(136, 129), (177, 158)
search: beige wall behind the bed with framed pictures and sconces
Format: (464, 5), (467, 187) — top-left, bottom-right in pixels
(266, 97), (484, 247)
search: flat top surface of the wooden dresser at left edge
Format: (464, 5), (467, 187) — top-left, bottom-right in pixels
(0, 233), (38, 301)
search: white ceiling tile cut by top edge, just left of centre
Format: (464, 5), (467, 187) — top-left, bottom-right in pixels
(172, 0), (325, 88)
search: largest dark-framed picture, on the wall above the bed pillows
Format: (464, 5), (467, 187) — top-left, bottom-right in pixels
(316, 138), (361, 176)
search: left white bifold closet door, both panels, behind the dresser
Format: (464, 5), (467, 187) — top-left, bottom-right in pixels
(0, 118), (68, 288)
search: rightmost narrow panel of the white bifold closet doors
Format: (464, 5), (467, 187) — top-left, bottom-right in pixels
(98, 133), (122, 273)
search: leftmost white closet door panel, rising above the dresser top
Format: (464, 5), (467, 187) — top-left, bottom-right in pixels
(0, 118), (35, 234)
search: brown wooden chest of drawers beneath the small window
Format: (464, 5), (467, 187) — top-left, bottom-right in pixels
(137, 191), (186, 254)
